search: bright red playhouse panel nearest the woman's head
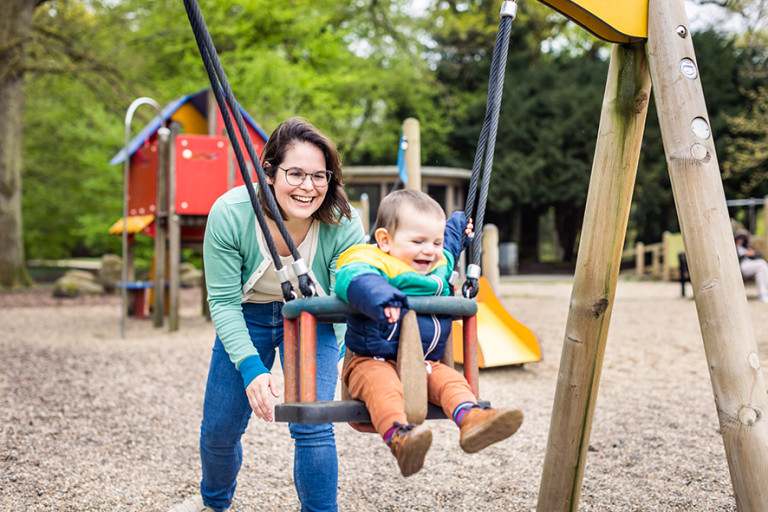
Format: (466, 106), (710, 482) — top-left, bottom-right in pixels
(174, 135), (229, 215)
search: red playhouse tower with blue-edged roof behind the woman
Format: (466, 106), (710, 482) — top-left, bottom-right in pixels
(110, 89), (267, 335)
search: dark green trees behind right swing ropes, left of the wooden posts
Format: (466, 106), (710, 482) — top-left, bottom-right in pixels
(426, 1), (607, 261)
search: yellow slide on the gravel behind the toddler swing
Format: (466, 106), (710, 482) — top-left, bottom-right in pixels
(453, 277), (541, 368)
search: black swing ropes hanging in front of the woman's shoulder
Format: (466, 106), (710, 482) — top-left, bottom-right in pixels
(184, 0), (316, 302)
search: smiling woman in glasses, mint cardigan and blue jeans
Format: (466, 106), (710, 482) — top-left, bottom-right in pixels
(184, 119), (364, 511)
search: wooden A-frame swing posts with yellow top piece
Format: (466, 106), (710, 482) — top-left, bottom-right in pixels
(537, 0), (768, 512)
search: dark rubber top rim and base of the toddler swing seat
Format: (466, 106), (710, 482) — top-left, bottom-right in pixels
(275, 296), (490, 423)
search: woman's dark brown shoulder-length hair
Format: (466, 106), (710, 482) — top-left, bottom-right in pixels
(259, 117), (352, 225)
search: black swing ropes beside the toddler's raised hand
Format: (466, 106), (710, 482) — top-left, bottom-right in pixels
(452, 0), (517, 298)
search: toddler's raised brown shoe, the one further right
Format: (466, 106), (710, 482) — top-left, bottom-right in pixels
(459, 407), (523, 453)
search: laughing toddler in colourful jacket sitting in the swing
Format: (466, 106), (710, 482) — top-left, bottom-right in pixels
(336, 190), (523, 476)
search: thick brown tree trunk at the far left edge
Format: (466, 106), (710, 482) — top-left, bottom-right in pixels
(0, 0), (45, 288)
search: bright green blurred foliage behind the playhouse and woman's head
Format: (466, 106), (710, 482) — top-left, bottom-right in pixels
(23, 0), (446, 258)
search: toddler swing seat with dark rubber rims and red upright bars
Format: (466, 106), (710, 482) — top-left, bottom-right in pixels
(275, 296), (484, 423)
